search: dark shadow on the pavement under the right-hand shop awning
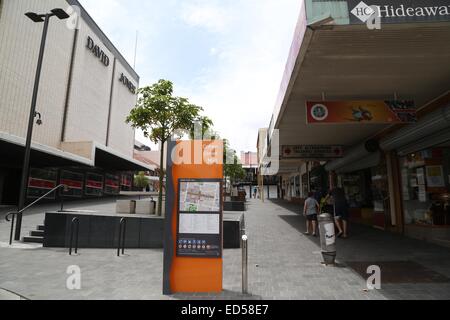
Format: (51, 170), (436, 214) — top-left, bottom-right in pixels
(272, 201), (450, 299)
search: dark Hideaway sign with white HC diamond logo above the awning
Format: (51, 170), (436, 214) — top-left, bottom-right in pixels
(348, 0), (450, 24)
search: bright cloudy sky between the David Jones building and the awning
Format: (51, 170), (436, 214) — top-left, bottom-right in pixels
(80, 0), (301, 151)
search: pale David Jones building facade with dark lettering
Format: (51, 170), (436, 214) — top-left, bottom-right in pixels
(0, 0), (150, 203)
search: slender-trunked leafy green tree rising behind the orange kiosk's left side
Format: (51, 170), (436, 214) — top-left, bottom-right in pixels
(126, 80), (212, 215)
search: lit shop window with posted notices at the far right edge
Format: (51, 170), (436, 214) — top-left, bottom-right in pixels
(401, 148), (450, 226)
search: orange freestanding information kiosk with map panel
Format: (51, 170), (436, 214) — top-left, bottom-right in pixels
(163, 141), (223, 295)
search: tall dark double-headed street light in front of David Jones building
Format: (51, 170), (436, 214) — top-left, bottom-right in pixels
(14, 9), (69, 241)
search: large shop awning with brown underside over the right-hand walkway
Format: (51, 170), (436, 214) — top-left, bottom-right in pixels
(268, 1), (450, 176)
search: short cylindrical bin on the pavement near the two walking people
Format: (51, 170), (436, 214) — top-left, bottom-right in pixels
(318, 213), (336, 265)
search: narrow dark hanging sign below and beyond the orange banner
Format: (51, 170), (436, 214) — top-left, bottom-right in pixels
(281, 145), (344, 160)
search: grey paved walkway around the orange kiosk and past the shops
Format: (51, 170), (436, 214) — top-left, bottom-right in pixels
(0, 200), (450, 300)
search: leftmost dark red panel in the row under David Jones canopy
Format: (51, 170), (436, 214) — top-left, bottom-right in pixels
(27, 169), (58, 199)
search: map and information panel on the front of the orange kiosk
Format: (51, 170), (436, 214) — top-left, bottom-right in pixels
(177, 179), (222, 258)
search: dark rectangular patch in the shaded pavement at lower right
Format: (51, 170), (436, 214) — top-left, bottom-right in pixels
(346, 261), (450, 283)
